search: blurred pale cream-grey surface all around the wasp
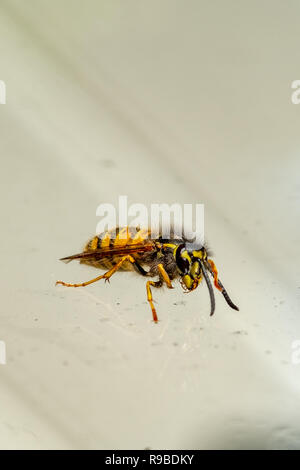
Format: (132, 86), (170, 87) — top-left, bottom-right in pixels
(0, 0), (300, 449)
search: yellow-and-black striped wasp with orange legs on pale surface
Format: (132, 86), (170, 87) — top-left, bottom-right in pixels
(56, 227), (239, 323)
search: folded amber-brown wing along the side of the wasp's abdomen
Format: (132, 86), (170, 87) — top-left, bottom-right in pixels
(60, 243), (156, 263)
